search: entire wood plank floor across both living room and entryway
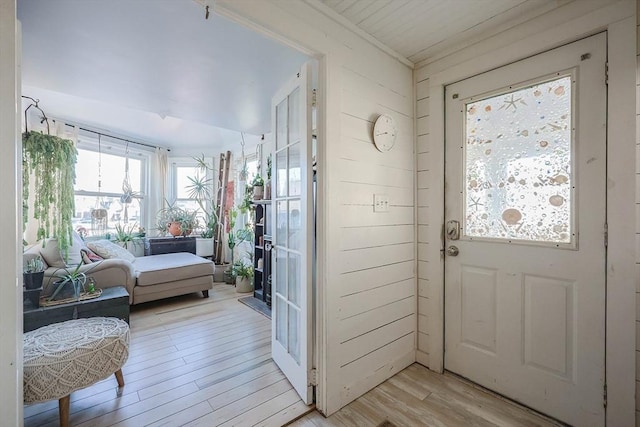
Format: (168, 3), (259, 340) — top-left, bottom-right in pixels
(25, 284), (557, 427)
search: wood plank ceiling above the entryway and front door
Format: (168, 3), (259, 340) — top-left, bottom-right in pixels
(322, 0), (569, 64)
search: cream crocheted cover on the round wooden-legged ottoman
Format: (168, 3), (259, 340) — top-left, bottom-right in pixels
(23, 317), (129, 403)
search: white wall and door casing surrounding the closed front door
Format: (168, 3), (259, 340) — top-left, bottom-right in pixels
(415, 0), (640, 426)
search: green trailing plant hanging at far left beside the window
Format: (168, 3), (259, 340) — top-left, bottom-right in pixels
(22, 131), (78, 258)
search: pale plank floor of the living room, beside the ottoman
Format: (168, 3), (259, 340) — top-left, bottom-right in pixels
(23, 283), (312, 427)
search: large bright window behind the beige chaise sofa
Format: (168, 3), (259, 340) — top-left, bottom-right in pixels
(73, 137), (150, 236)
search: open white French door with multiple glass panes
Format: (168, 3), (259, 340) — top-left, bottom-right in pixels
(271, 64), (313, 404)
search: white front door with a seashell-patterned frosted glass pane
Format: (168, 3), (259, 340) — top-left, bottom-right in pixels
(444, 34), (606, 426)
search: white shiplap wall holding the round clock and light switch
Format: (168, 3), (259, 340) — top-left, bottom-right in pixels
(216, 0), (417, 414)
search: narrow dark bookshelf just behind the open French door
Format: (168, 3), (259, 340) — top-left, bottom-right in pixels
(253, 200), (271, 306)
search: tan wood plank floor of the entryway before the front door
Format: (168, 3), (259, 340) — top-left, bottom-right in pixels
(290, 363), (562, 427)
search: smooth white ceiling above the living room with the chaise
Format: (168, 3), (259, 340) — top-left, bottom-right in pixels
(18, 0), (307, 150)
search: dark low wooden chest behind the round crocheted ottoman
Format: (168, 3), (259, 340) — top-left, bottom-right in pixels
(23, 286), (129, 332)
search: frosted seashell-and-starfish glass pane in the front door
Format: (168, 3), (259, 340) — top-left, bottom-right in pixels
(463, 75), (575, 246)
